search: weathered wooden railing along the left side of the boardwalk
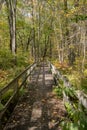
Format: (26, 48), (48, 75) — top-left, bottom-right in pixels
(0, 63), (36, 120)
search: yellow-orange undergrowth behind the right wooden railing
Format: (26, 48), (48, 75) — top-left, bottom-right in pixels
(53, 60), (87, 93)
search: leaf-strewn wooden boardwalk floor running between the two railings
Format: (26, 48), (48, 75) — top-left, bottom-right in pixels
(4, 63), (66, 130)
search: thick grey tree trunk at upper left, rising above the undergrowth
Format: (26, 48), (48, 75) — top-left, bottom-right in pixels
(6, 0), (17, 56)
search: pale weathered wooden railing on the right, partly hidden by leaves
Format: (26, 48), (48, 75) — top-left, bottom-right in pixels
(49, 62), (87, 109)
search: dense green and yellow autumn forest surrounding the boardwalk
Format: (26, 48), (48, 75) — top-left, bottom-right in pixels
(0, 0), (87, 130)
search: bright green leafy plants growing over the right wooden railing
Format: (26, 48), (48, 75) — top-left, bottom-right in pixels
(54, 76), (87, 130)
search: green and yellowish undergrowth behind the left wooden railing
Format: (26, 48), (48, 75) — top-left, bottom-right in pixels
(0, 49), (33, 89)
